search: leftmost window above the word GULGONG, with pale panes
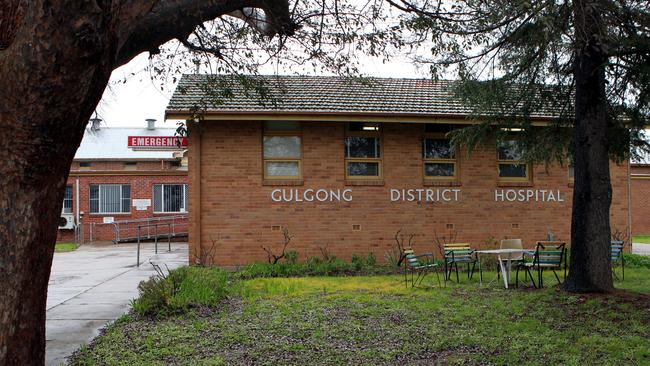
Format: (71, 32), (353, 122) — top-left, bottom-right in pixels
(263, 121), (302, 179)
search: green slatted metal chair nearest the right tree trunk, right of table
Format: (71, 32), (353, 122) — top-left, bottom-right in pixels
(515, 241), (566, 288)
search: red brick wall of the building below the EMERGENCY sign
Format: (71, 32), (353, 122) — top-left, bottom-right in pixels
(57, 161), (188, 241)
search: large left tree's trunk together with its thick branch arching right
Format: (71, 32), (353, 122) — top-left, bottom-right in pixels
(0, 0), (295, 365)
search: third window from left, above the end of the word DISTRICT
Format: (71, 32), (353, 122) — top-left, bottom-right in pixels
(422, 125), (457, 180)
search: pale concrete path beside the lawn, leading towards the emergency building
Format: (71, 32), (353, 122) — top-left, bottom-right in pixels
(45, 243), (188, 365)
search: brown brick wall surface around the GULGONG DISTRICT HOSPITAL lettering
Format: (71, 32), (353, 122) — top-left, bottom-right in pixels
(189, 121), (629, 265)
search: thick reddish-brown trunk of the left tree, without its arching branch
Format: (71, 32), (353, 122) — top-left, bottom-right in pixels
(0, 2), (114, 365)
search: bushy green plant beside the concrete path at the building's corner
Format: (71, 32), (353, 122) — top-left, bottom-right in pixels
(132, 267), (228, 316)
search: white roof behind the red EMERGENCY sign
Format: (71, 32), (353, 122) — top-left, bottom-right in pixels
(74, 127), (176, 160)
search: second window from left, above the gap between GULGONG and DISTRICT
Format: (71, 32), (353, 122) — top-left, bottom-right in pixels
(345, 122), (382, 179)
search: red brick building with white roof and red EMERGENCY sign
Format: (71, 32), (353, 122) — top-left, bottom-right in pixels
(58, 120), (188, 241)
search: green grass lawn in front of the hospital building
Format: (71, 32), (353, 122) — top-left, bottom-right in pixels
(71, 268), (650, 365)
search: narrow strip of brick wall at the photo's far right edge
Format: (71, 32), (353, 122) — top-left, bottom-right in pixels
(630, 165), (650, 235)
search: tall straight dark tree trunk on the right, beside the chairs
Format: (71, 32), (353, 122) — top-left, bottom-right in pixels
(564, 1), (613, 292)
